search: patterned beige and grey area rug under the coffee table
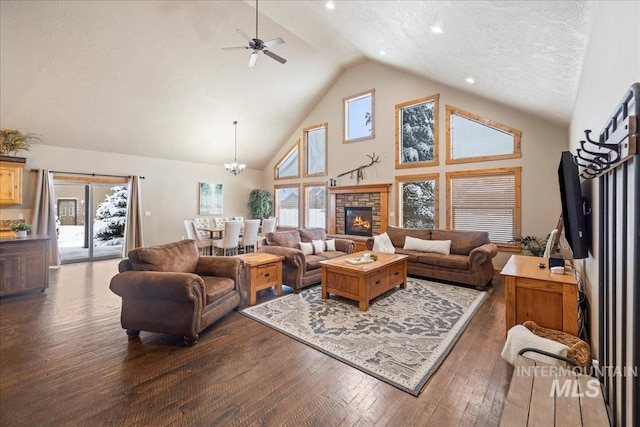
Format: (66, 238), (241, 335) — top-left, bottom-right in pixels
(242, 278), (489, 396)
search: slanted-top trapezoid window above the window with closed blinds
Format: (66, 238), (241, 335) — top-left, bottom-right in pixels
(447, 105), (522, 163)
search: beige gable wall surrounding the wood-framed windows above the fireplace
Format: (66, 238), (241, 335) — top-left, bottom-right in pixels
(264, 62), (568, 268)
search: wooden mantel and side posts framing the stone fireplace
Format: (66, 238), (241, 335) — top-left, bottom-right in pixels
(327, 184), (392, 234)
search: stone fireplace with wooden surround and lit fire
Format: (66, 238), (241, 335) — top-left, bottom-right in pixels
(327, 184), (391, 240)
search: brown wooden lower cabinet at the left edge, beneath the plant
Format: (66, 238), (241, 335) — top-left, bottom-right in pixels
(0, 236), (50, 296)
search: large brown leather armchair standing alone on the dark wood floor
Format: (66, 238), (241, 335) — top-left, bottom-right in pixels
(109, 240), (242, 345)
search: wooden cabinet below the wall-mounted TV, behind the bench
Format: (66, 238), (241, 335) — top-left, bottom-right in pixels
(500, 255), (578, 336)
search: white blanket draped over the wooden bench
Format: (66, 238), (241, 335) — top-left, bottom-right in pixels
(502, 325), (569, 366)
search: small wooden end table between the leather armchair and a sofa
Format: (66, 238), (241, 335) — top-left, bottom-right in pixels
(237, 252), (284, 305)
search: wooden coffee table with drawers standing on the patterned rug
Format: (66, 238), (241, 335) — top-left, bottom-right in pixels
(320, 251), (408, 311)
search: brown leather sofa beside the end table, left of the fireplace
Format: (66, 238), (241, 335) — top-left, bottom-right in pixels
(258, 228), (356, 293)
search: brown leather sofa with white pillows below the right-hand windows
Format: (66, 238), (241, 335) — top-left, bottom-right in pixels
(367, 226), (498, 289)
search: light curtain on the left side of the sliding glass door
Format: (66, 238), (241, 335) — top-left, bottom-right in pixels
(31, 169), (60, 267)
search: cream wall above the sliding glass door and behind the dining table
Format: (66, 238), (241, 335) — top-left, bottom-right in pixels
(0, 144), (262, 245)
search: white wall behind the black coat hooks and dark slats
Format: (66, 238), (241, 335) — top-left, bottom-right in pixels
(569, 1), (640, 425)
